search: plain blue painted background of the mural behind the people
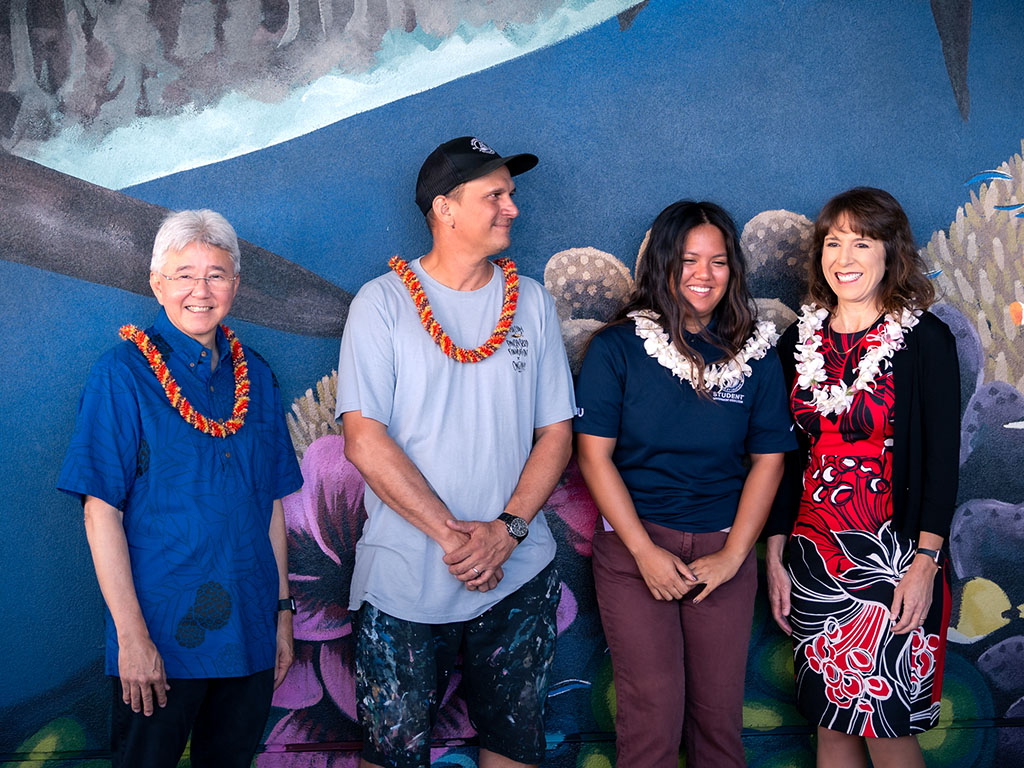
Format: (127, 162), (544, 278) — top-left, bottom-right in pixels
(0, 0), (1024, 765)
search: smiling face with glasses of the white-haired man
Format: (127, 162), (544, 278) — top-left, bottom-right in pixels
(150, 243), (239, 349)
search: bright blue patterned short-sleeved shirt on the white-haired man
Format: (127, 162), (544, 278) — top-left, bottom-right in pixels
(57, 310), (302, 678)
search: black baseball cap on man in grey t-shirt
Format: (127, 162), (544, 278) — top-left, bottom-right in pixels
(416, 136), (538, 216)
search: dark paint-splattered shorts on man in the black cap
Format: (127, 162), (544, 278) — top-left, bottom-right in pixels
(355, 565), (561, 768)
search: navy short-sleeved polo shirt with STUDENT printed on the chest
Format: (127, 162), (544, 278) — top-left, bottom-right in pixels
(573, 321), (797, 534)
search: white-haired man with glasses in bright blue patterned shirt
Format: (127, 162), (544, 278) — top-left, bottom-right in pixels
(57, 210), (302, 768)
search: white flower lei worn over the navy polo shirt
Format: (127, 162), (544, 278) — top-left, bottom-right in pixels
(627, 309), (778, 389)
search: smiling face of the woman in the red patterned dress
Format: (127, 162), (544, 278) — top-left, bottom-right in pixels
(821, 216), (886, 309)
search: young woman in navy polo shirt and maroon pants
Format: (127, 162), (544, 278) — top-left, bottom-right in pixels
(574, 201), (796, 768)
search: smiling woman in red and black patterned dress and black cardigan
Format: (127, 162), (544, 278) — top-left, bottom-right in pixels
(767, 187), (959, 768)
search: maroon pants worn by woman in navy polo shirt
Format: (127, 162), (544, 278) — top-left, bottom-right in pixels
(594, 522), (758, 768)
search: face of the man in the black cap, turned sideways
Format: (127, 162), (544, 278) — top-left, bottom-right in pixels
(441, 166), (519, 258)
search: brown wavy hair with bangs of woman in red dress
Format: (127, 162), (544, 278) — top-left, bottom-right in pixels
(807, 186), (935, 313)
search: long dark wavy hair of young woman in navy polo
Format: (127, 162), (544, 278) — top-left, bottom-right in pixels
(608, 200), (756, 393)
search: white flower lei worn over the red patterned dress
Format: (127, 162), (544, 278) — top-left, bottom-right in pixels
(796, 304), (921, 416)
